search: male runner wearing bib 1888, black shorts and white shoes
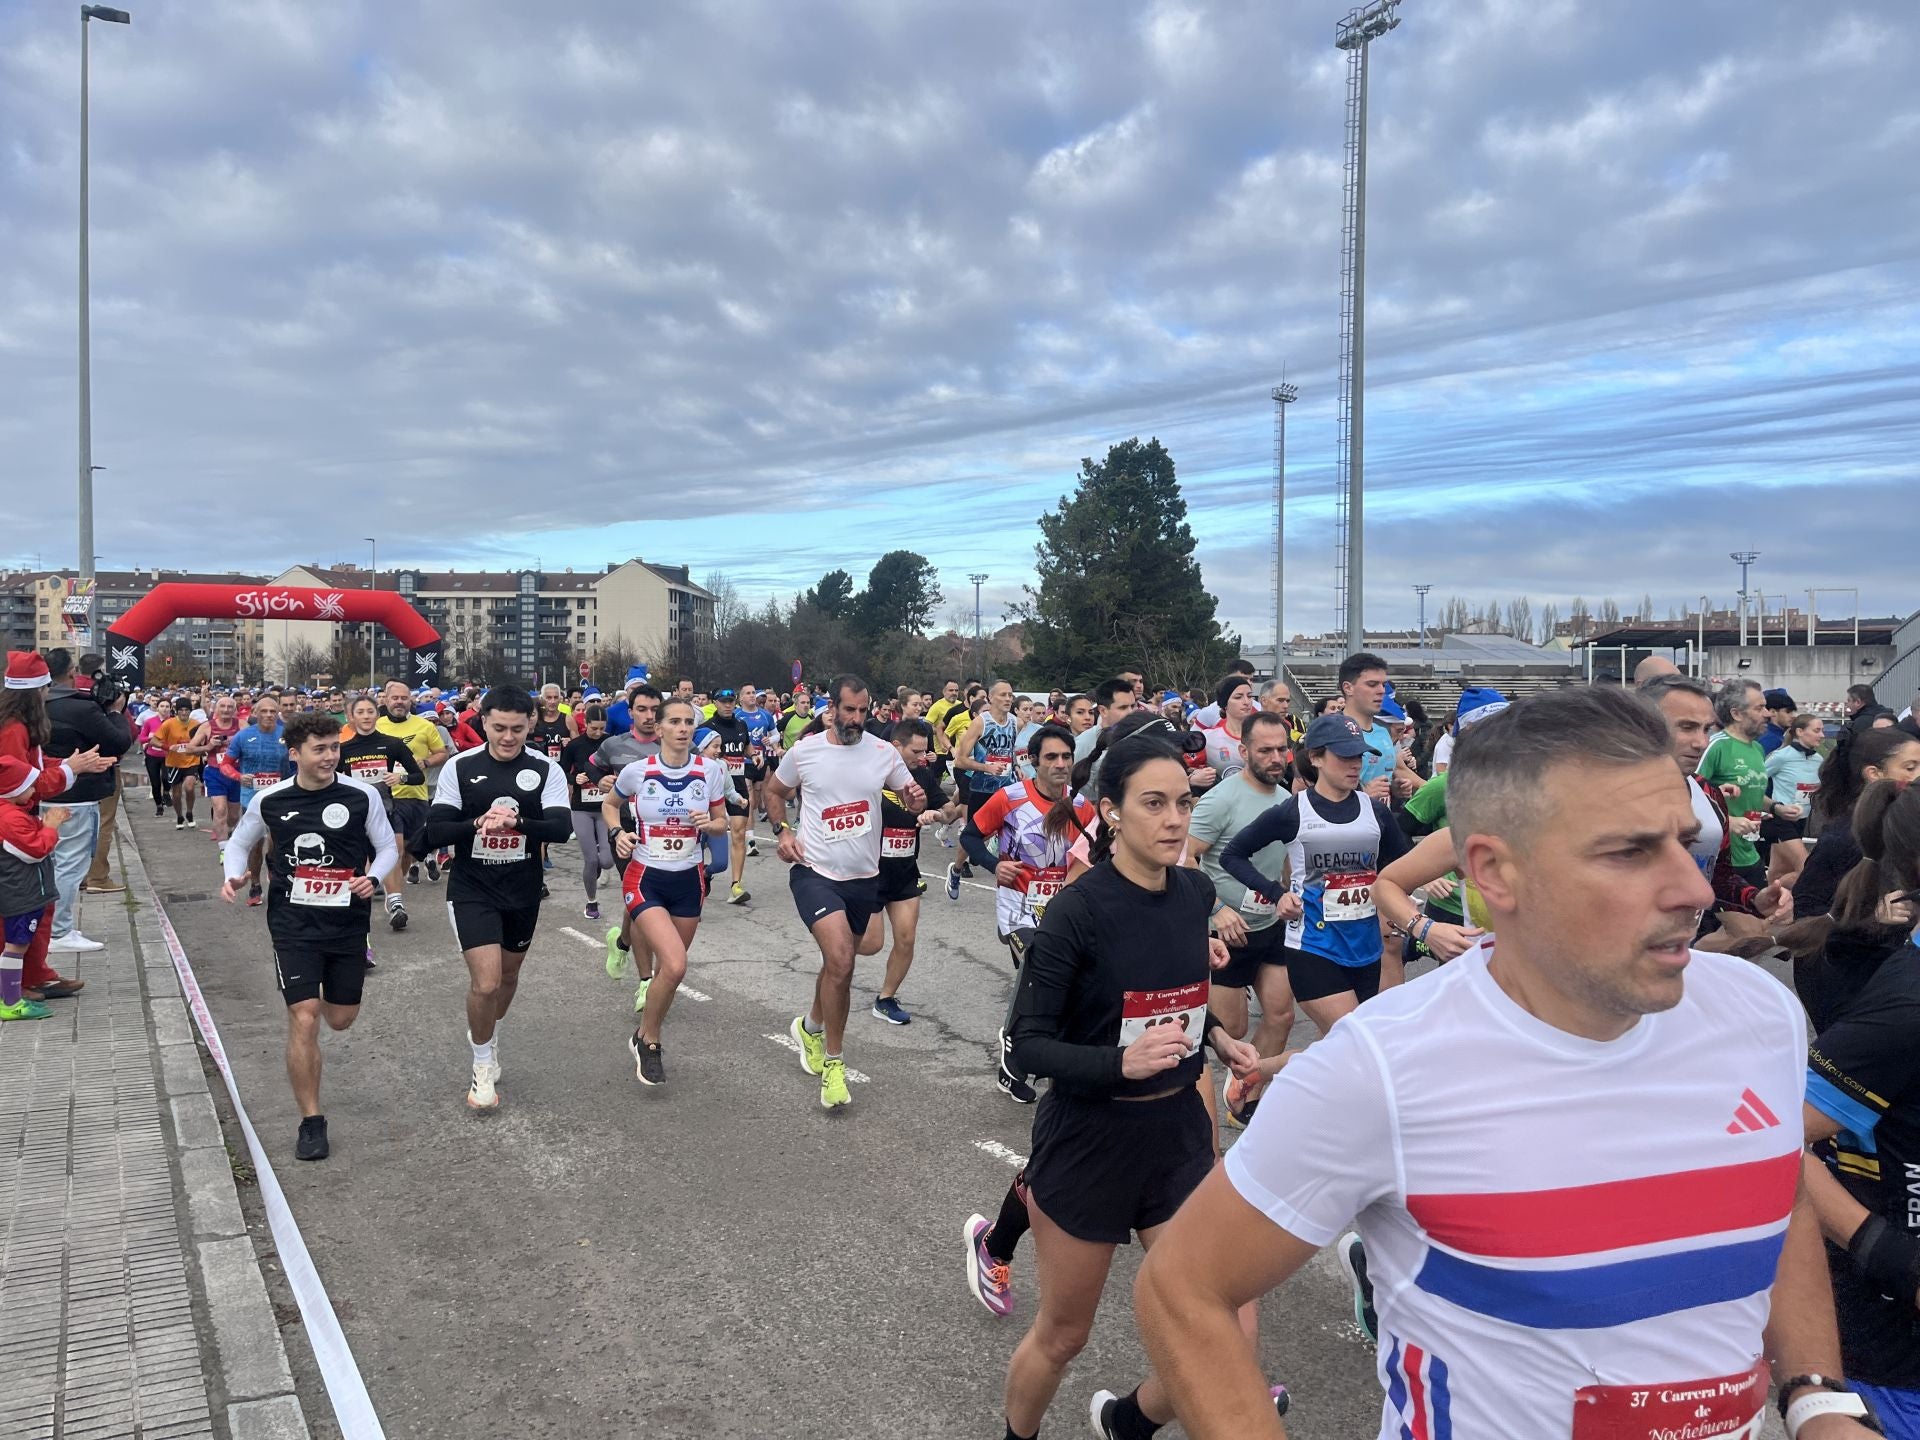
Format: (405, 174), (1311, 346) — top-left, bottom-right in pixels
(426, 685), (574, 1110)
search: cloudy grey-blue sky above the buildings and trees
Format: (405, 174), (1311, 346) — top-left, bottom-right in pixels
(0, 0), (1920, 643)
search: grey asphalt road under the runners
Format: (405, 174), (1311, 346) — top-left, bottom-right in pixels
(129, 806), (1380, 1440)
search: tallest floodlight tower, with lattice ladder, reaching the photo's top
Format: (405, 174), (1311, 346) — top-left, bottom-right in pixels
(1332, 0), (1400, 653)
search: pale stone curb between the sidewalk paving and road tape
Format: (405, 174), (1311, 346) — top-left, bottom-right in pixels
(117, 804), (309, 1440)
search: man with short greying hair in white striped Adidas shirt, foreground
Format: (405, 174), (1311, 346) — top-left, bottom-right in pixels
(1135, 685), (1868, 1440)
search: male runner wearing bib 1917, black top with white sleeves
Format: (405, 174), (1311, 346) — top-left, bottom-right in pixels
(221, 712), (399, 1160)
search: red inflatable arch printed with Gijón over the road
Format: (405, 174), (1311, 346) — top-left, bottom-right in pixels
(108, 580), (440, 687)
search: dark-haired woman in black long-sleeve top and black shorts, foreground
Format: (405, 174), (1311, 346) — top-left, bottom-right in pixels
(1006, 735), (1258, 1440)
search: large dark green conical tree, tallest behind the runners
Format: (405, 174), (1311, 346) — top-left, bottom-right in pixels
(1012, 438), (1238, 689)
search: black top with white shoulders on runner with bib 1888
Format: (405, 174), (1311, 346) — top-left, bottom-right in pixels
(426, 745), (574, 910)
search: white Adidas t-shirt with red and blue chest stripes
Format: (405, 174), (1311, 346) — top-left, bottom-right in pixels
(1227, 937), (1807, 1440)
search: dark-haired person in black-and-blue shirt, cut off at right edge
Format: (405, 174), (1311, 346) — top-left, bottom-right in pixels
(1789, 780), (1920, 1436)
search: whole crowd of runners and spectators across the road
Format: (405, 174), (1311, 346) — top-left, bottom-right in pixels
(0, 653), (1920, 1440)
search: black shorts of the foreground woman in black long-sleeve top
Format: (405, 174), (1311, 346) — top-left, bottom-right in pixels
(1027, 1085), (1213, 1244)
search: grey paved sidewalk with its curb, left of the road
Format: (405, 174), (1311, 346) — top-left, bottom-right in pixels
(0, 804), (307, 1440)
